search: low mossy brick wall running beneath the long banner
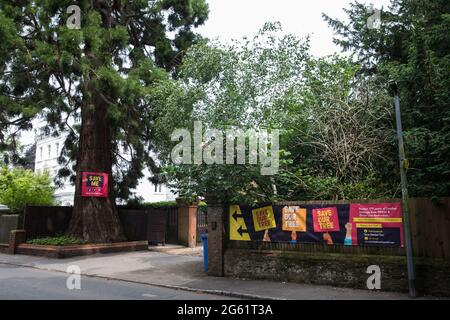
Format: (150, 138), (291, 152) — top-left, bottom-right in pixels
(224, 249), (450, 297)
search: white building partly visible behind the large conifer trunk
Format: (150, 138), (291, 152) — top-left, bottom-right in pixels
(35, 134), (176, 205)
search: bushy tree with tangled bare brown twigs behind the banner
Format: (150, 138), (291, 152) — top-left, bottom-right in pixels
(280, 56), (395, 199)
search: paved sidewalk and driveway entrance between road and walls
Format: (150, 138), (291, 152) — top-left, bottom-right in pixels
(0, 251), (428, 300)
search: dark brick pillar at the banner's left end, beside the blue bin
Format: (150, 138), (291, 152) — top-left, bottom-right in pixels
(205, 196), (225, 277)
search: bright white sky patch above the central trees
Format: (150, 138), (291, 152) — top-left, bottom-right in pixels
(197, 0), (390, 56)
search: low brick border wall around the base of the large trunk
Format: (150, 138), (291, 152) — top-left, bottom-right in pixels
(15, 241), (148, 259)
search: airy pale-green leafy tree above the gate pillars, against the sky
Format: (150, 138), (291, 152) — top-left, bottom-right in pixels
(155, 23), (309, 203)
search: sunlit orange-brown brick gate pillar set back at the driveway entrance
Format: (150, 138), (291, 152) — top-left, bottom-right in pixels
(177, 199), (197, 248)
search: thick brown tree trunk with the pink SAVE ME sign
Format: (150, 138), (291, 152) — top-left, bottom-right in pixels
(68, 99), (125, 242)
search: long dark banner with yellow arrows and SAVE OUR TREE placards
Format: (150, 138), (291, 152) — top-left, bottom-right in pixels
(229, 203), (403, 247)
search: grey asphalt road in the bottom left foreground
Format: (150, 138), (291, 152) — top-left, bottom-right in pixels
(0, 264), (234, 300)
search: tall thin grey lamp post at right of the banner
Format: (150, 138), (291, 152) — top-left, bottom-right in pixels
(389, 81), (417, 298)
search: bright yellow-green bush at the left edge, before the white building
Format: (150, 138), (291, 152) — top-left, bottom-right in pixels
(0, 166), (55, 213)
